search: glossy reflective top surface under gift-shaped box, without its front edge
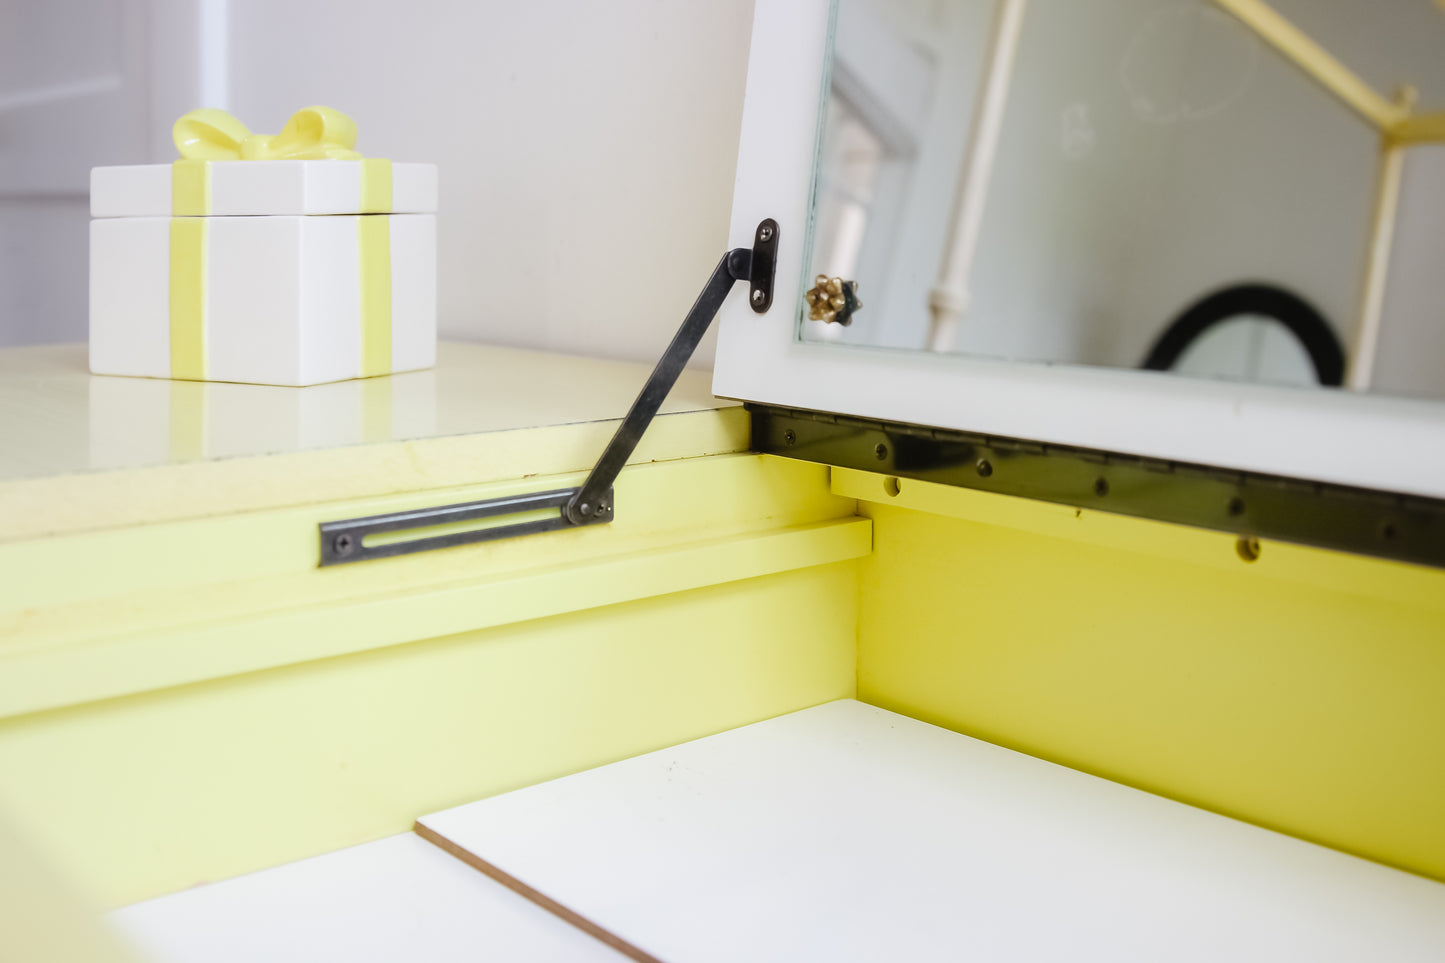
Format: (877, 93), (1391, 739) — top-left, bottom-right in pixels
(0, 343), (731, 482)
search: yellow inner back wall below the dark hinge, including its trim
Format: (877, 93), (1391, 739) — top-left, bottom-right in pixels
(834, 470), (1445, 879)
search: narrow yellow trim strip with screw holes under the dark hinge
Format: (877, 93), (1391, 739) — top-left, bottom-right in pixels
(831, 468), (1445, 610)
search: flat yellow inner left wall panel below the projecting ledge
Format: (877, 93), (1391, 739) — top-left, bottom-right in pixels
(0, 562), (857, 905)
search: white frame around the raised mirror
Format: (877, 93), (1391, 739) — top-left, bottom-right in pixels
(712, 0), (1445, 497)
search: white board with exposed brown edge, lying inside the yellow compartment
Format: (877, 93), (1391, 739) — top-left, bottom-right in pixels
(420, 701), (1445, 963)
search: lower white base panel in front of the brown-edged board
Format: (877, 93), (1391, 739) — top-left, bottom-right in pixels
(110, 833), (626, 963)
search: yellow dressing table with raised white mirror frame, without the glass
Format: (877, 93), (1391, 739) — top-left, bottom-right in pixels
(0, 1), (1445, 960)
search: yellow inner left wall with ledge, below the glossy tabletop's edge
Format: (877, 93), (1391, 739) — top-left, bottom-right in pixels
(0, 454), (871, 905)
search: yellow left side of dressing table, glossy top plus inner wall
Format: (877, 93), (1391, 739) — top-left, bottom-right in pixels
(0, 339), (871, 905)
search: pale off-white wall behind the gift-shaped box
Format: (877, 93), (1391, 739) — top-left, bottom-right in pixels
(0, 0), (751, 363)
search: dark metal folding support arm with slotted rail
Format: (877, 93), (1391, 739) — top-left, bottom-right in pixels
(321, 218), (777, 565)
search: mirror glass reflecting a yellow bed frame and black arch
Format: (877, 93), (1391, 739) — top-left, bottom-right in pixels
(799, 0), (1445, 398)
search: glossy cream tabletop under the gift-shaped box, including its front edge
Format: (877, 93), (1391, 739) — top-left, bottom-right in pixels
(0, 343), (747, 541)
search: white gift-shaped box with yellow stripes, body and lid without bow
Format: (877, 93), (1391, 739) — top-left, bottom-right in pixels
(90, 161), (436, 386)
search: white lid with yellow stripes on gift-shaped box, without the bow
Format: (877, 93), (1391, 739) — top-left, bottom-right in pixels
(91, 159), (436, 217)
